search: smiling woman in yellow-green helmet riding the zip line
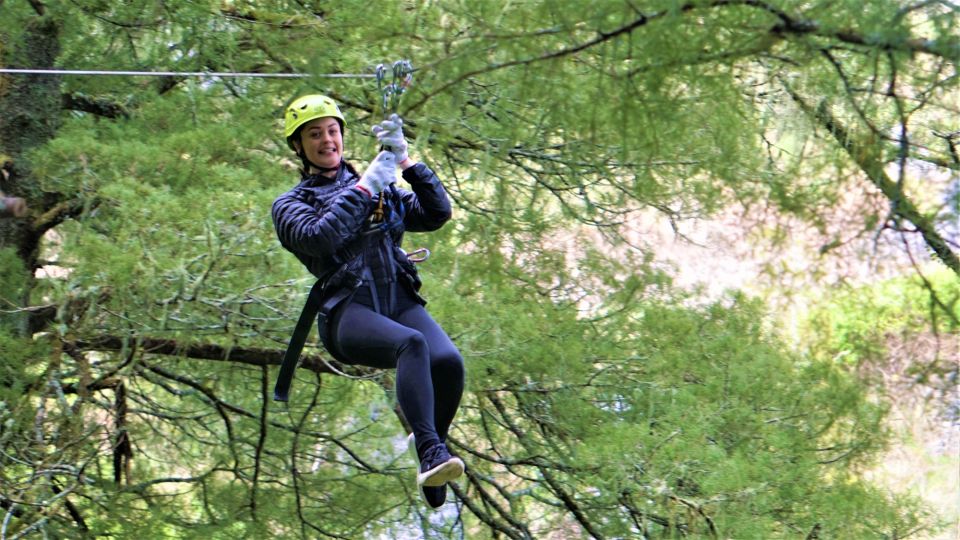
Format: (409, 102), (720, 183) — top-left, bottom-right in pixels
(272, 94), (464, 508)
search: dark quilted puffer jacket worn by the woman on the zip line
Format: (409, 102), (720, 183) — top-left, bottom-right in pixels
(272, 163), (451, 302)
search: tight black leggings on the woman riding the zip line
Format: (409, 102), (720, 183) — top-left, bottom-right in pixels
(331, 287), (464, 456)
